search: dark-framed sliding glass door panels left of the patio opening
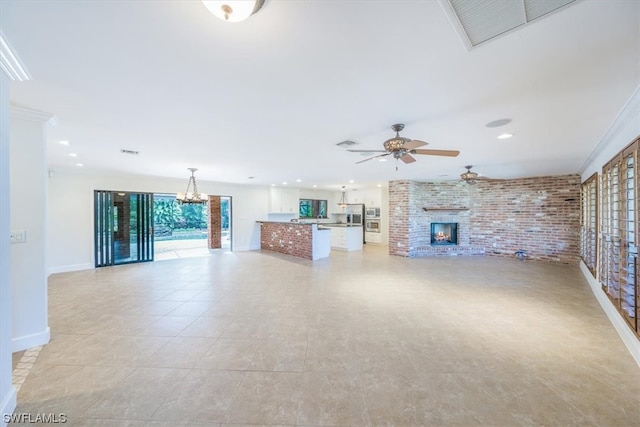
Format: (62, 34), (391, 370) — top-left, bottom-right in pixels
(94, 190), (153, 267)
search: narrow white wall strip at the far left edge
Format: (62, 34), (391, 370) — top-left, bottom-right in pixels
(0, 67), (16, 426)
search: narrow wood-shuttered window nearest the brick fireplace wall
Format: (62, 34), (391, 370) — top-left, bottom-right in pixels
(580, 173), (598, 277)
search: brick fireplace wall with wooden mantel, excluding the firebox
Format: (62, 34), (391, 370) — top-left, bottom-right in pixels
(389, 175), (580, 263)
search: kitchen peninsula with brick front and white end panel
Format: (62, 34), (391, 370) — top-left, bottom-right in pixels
(258, 221), (331, 261)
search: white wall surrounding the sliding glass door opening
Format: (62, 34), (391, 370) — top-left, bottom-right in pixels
(47, 168), (269, 273)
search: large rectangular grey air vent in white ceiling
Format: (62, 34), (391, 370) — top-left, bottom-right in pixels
(440, 0), (578, 50)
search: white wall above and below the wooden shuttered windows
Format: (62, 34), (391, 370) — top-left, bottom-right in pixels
(580, 86), (640, 365)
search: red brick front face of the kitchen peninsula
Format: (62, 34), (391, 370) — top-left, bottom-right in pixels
(260, 222), (313, 259)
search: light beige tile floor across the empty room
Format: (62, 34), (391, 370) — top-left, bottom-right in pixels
(10, 245), (640, 427)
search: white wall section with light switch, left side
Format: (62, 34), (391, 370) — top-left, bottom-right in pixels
(9, 108), (51, 352)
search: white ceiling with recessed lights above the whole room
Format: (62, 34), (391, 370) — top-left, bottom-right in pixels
(0, 0), (640, 188)
